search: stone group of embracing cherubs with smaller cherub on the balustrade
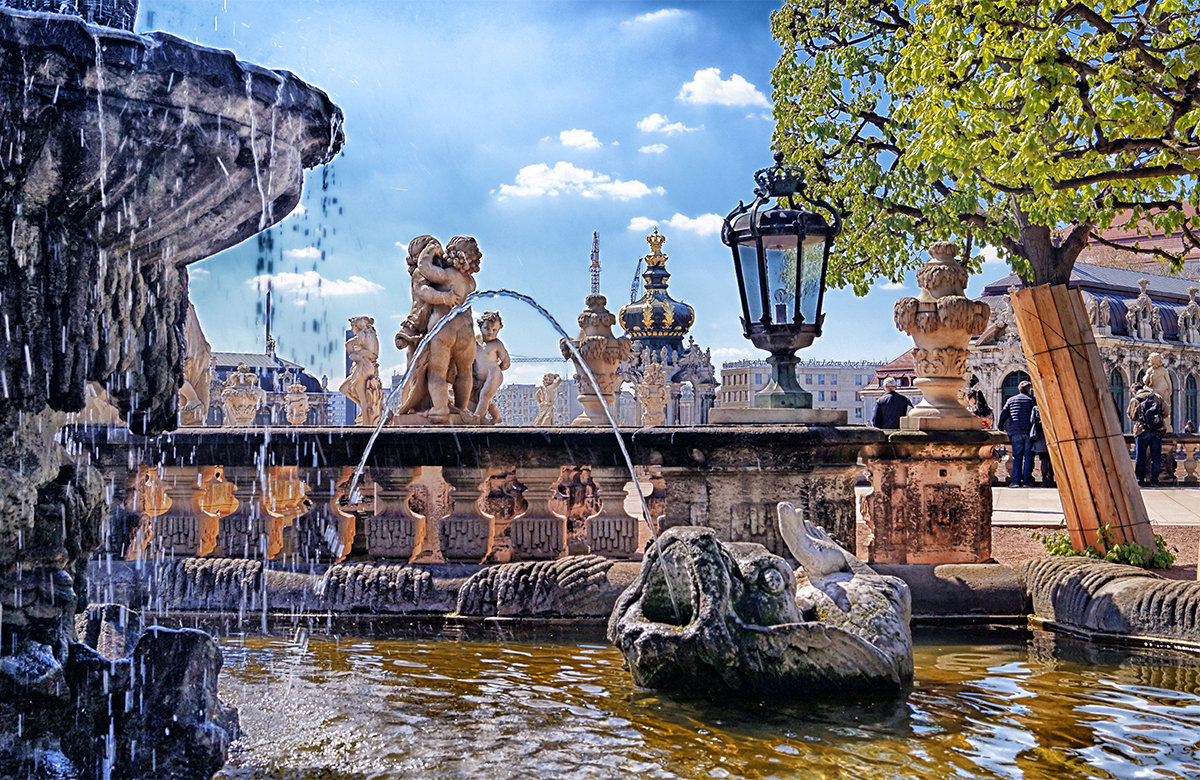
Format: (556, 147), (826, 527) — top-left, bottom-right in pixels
(396, 235), (511, 425)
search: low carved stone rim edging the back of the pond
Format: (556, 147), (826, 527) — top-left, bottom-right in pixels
(90, 558), (1200, 653)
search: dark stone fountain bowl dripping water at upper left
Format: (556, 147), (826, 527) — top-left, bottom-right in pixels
(0, 10), (344, 264)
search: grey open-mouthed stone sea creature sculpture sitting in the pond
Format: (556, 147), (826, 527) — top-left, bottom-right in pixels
(608, 502), (912, 696)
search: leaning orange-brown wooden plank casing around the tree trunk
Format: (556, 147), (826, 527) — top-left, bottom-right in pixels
(1012, 284), (1154, 551)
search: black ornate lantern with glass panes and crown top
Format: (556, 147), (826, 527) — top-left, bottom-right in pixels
(721, 152), (841, 409)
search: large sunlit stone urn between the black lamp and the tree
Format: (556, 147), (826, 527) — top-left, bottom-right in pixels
(895, 241), (991, 431)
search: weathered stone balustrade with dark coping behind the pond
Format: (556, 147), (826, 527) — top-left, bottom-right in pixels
(77, 426), (884, 564)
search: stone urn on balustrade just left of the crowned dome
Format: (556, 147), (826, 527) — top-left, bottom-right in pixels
(559, 294), (632, 425)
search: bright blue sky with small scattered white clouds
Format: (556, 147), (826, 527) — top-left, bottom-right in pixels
(137, 0), (1004, 383)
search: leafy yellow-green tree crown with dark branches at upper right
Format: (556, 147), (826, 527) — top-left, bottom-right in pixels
(772, 0), (1200, 294)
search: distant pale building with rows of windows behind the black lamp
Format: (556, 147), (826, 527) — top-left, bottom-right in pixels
(718, 360), (883, 425)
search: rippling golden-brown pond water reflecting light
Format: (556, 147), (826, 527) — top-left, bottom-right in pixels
(218, 631), (1200, 780)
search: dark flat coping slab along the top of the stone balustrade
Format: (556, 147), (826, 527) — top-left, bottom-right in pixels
(70, 425), (884, 472)
